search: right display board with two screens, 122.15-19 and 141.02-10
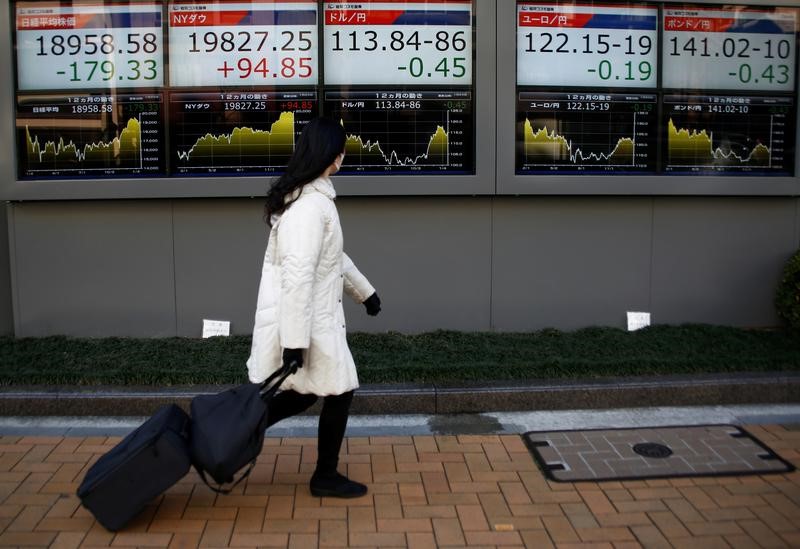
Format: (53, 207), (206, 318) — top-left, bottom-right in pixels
(515, 1), (798, 176)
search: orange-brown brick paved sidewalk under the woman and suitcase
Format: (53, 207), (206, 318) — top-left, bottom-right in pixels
(0, 426), (800, 549)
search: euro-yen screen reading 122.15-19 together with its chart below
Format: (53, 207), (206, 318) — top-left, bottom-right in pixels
(515, 1), (658, 174)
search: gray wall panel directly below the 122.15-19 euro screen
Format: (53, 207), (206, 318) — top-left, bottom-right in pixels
(492, 197), (652, 331)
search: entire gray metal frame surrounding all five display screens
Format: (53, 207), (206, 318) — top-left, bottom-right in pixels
(0, 0), (800, 200)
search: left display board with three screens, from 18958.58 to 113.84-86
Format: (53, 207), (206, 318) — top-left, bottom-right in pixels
(12, 0), (475, 180)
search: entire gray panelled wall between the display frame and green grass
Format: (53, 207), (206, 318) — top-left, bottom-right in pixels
(7, 197), (800, 337)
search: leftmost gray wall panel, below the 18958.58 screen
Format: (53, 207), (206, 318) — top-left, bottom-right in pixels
(13, 201), (175, 337)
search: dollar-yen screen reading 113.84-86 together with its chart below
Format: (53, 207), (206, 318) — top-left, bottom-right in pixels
(324, 0), (475, 174)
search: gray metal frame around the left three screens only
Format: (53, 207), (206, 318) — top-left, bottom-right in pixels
(0, 0), (496, 201)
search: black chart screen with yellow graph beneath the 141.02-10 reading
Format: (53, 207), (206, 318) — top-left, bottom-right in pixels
(663, 95), (795, 176)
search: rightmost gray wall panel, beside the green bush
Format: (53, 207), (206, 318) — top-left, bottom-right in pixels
(652, 198), (797, 326)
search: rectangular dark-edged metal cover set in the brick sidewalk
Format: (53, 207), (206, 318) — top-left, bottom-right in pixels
(523, 425), (794, 482)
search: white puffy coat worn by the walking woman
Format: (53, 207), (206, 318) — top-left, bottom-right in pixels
(247, 177), (375, 396)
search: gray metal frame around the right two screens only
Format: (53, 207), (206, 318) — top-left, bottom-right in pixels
(497, 0), (800, 196)
